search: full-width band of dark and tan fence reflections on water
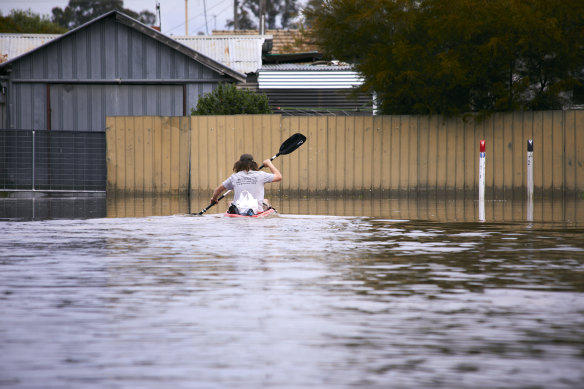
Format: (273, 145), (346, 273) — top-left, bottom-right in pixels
(0, 193), (584, 226)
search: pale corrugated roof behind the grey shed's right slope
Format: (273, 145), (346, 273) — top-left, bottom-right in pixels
(172, 35), (272, 74)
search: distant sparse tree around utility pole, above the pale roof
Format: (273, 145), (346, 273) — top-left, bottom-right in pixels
(227, 0), (299, 30)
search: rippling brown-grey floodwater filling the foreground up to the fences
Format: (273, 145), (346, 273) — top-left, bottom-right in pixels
(0, 194), (584, 389)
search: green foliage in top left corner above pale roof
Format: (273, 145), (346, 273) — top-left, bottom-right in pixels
(0, 9), (67, 34)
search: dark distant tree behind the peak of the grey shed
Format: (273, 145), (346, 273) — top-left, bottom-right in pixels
(52, 0), (156, 29)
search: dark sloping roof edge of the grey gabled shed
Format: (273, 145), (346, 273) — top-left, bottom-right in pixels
(0, 10), (245, 82)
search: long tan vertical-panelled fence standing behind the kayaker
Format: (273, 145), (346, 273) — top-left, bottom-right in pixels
(106, 110), (584, 199)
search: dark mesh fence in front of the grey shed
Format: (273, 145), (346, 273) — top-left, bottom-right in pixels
(0, 130), (106, 192)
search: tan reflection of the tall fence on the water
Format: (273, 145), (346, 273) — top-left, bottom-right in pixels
(102, 196), (584, 225)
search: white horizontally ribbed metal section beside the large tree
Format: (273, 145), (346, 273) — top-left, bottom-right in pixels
(258, 64), (363, 90)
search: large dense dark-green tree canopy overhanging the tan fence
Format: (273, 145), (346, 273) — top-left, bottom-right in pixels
(304, 0), (584, 115)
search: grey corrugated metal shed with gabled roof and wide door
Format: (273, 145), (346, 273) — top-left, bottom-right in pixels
(0, 11), (245, 131)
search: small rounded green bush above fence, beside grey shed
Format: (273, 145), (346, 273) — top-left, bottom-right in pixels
(191, 84), (272, 115)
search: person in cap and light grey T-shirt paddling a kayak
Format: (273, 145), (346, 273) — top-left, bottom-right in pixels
(211, 154), (282, 215)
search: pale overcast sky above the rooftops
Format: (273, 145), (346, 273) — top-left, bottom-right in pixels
(0, 0), (290, 35)
